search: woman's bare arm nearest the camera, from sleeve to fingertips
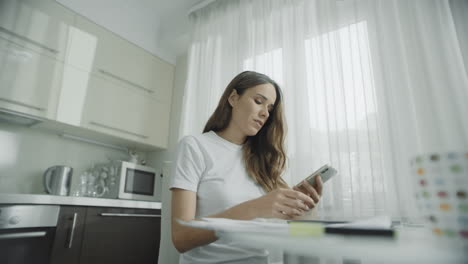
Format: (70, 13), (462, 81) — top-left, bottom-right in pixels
(172, 188), (315, 253)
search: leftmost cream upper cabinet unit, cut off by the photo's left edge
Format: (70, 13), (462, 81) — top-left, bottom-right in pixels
(0, 0), (74, 118)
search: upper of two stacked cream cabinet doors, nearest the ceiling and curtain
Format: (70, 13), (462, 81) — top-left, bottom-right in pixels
(68, 16), (174, 101)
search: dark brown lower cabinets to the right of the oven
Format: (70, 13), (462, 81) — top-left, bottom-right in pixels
(52, 207), (161, 264)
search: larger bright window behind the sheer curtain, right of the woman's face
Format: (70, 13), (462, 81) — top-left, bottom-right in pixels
(305, 21), (385, 216)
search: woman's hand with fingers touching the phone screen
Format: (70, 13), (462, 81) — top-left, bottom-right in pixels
(247, 188), (315, 219)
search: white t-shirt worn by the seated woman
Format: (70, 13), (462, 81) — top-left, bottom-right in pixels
(170, 131), (268, 264)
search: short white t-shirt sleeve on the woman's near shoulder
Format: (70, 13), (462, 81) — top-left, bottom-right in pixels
(170, 136), (205, 192)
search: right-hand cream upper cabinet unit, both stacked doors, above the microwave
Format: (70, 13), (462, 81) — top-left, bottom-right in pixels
(65, 16), (174, 148)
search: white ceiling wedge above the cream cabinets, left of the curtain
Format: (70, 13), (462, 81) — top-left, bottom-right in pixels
(56, 0), (207, 64)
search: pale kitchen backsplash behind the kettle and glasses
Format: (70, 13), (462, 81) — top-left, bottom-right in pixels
(0, 122), (146, 194)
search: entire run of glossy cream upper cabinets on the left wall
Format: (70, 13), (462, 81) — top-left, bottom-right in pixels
(0, 0), (174, 150)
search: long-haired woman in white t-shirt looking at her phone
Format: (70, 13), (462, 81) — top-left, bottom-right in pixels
(171, 71), (322, 263)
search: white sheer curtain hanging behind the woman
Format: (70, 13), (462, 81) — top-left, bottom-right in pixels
(180, 0), (468, 221)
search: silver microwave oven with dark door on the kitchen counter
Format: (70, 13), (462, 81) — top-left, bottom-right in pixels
(100, 161), (161, 201)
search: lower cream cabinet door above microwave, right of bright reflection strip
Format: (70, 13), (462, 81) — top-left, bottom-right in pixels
(82, 75), (170, 148)
